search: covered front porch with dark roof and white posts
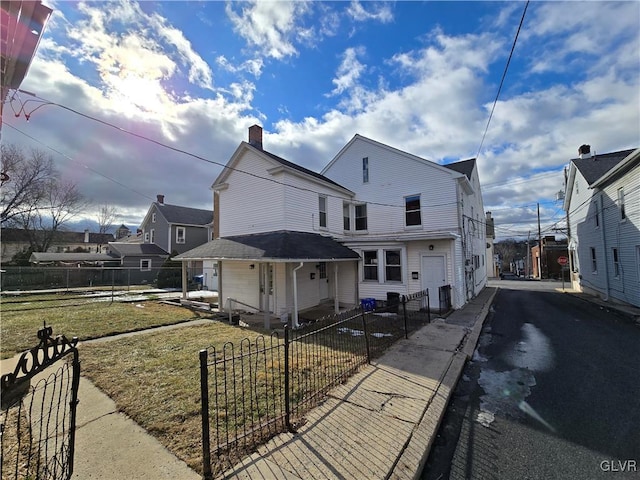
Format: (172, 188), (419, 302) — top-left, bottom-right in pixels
(175, 230), (360, 327)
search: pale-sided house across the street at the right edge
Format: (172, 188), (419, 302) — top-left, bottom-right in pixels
(564, 145), (640, 306)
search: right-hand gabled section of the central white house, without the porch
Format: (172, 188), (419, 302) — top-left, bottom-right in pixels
(317, 135), (490, 308)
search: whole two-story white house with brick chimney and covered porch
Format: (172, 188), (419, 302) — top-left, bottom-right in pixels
(176, 125), (487, 323)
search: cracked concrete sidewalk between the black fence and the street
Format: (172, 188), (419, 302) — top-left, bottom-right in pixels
(223, 288), (497, 480)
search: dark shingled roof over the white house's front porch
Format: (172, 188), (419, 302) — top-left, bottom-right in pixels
(174, 230), (360, 262)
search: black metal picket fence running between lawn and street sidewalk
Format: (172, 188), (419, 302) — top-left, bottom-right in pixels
(200, 290), (431, 479)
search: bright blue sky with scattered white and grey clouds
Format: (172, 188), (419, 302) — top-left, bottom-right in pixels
(2, 0), (640, 238)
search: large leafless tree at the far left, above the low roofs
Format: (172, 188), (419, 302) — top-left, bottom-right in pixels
(2, 146), (88, 252)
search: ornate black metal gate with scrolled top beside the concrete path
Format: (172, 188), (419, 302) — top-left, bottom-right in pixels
(0, 326), (80, 480)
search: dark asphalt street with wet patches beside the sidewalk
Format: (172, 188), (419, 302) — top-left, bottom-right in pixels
(422, 287), (640, 480)
